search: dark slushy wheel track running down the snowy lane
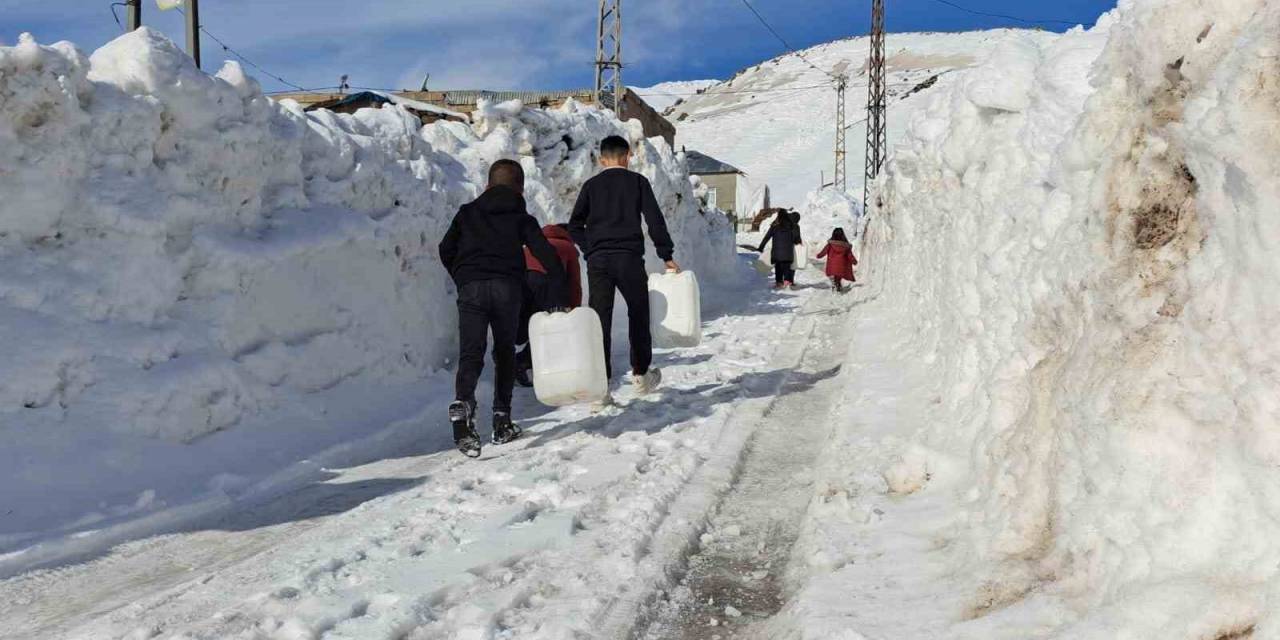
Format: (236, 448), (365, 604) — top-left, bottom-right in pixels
(643, 289), (858, 640)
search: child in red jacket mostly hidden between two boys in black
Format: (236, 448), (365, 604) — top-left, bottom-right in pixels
(516, 224), (582, 387)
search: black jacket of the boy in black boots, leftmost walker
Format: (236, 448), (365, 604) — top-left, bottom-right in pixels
(440, 187), (566, 306)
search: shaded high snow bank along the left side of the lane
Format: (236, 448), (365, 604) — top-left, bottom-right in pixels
(0, 29), (735, 535)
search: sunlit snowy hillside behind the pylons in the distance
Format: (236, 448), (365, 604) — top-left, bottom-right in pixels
(668, 29), (1056, 207)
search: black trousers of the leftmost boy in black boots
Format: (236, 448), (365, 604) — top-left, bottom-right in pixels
(456, 279), (522, 413)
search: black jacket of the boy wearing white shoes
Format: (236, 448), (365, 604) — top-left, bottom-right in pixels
(568, 169), (676, 260)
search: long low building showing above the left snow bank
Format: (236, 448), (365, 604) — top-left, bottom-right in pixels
(273, 88), (676, 146)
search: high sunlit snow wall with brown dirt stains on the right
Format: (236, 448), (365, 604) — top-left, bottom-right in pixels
(865, 0), (1280, 639)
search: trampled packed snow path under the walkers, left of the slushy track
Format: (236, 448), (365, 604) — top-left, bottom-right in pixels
(0, 263), (849, 639)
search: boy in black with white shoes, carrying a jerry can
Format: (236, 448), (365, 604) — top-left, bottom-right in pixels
(568, 136), (680, 402)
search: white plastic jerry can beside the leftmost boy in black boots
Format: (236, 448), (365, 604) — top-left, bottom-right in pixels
(529, 307), (609, 407)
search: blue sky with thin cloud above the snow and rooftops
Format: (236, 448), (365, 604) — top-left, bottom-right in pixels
(0, 0), (1115, 91)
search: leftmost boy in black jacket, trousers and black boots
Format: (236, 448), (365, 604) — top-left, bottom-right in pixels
(440, 160), (564, 457)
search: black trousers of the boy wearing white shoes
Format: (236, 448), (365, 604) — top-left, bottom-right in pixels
(586, 253), (653, 379)
